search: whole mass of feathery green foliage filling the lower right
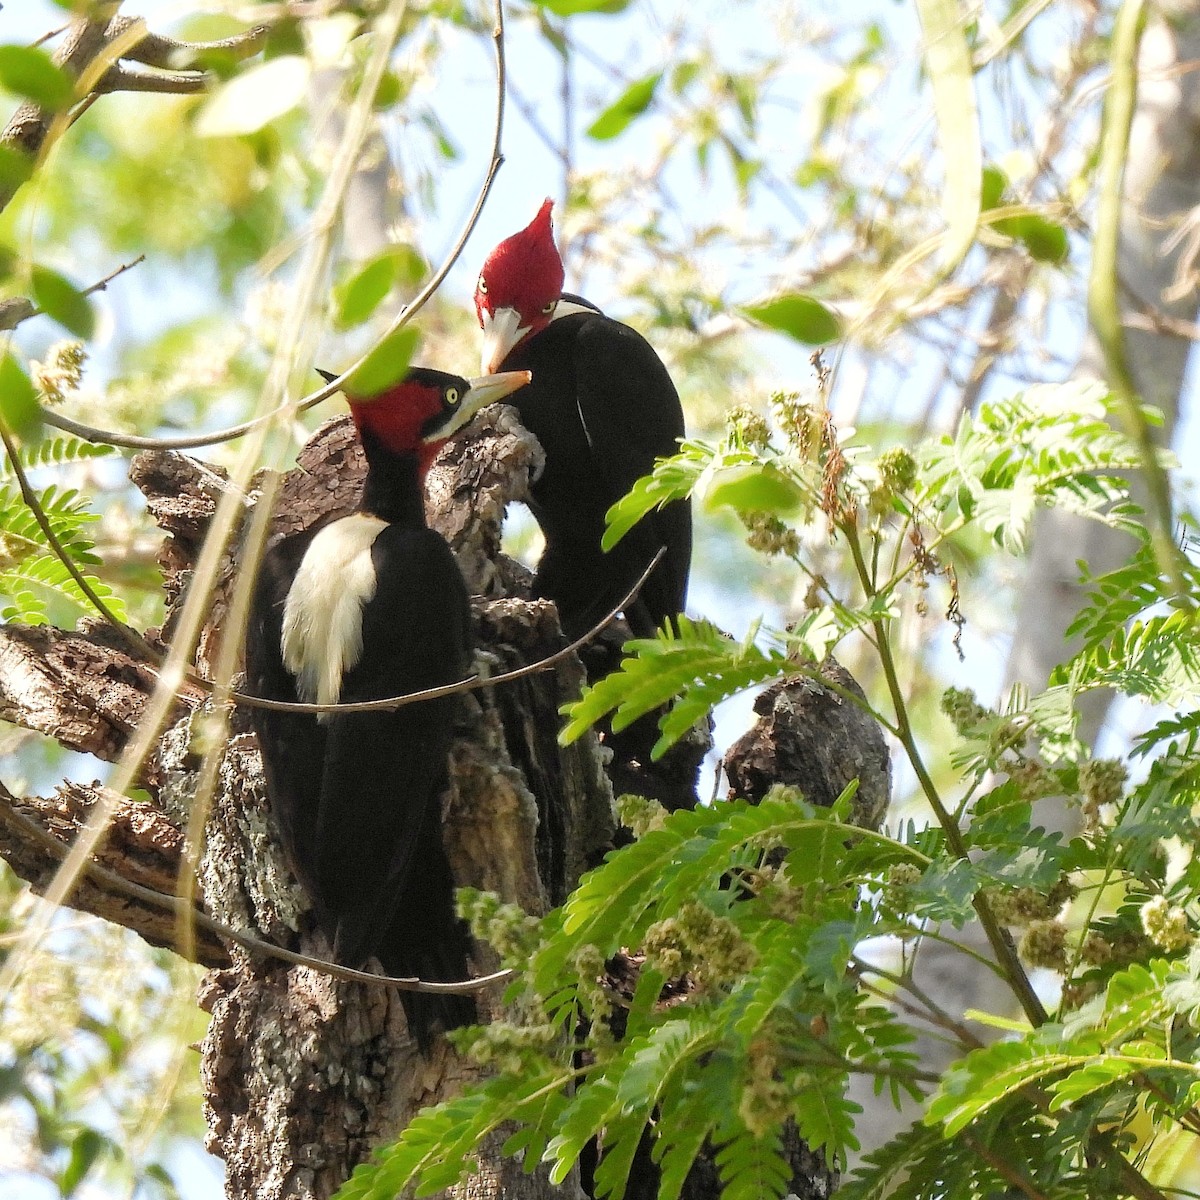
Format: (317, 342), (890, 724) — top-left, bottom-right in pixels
(347, 360), (1200, 1200)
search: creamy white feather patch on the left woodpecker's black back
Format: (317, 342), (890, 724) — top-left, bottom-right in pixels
(280, 512), (388, 719)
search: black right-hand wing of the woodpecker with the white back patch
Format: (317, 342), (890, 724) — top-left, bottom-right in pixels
(313, 526), (470, 973)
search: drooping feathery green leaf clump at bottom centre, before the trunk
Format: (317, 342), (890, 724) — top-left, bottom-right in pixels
(340, 796), (920, 1200)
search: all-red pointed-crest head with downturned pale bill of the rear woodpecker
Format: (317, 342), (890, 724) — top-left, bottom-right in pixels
(475, 200), (563, 371)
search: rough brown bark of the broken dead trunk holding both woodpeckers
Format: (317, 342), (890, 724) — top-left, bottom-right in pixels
(0, 407), (886, 1200)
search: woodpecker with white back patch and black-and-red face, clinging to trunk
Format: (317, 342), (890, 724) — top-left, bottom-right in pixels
(246, 367), (529, 1048)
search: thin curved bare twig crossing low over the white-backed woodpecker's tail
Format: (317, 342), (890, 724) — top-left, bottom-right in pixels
(0, 790), (514, 995)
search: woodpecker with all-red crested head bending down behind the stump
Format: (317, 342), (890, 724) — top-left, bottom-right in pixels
(475, 200), (691, 637)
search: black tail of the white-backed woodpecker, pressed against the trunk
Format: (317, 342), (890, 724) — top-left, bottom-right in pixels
(376, 845), (479, 1051)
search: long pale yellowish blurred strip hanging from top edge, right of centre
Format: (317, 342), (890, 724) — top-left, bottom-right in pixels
(917, 0), (983, 272)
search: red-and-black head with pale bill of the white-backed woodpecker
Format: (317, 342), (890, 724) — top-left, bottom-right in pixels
(331, 367), (529, 475)
